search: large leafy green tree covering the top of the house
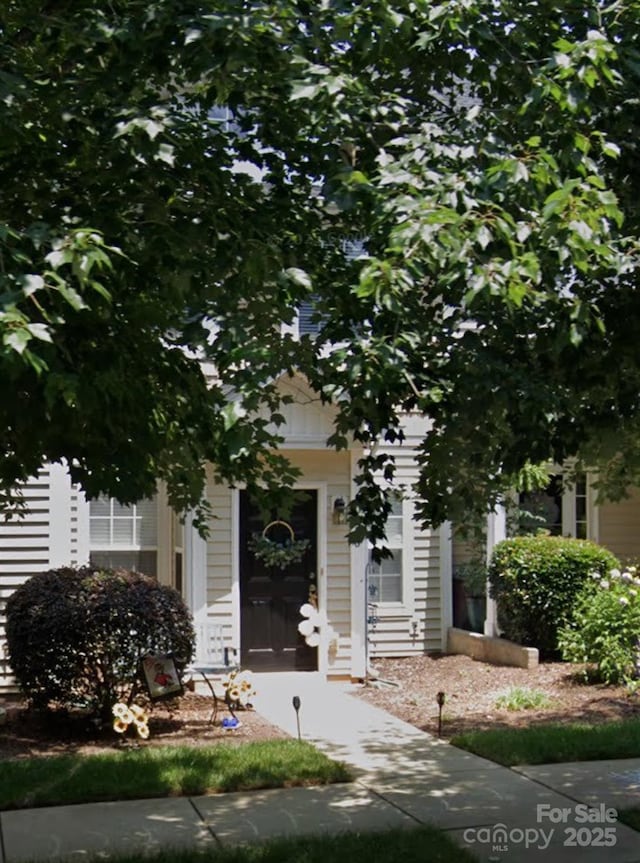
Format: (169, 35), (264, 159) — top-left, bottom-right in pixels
(0, 0), (640, 540)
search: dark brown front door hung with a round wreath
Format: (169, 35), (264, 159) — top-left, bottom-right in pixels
(240, 491), (318, 671)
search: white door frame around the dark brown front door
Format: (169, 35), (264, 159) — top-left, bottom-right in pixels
(231, 480), (329, 676)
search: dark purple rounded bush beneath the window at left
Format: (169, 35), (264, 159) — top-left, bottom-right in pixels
(6, 567), (195, 718)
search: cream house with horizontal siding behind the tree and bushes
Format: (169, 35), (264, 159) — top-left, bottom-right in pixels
(0, 376), (640, 691)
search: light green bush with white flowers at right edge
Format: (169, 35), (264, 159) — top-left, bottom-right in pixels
(558, 567), (640, 684)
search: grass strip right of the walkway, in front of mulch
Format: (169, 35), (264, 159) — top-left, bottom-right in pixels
(451, 719), (640, 767)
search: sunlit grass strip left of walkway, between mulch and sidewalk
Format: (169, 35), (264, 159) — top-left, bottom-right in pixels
(0, 740), (351, 809)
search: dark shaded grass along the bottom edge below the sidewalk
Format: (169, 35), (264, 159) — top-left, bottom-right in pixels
(80, 827), (477, 863)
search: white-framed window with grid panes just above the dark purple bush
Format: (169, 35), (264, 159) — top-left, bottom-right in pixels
(89, 497), (158, 576)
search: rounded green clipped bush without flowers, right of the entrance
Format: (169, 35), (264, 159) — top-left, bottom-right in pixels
(489, 536), (618, 656)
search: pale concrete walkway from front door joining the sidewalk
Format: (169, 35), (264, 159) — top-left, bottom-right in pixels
(0, 674), (640, 863)
